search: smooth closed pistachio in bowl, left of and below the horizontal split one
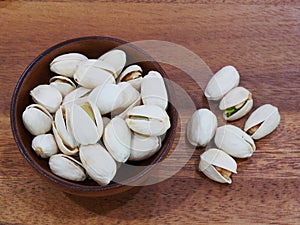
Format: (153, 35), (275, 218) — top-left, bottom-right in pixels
(103, 117), (131, 162)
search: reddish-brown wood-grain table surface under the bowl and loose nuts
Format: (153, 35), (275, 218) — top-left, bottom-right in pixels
(0, 0), (300, 224)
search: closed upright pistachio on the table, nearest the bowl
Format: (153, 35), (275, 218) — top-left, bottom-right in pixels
(187, 109), (218, 146)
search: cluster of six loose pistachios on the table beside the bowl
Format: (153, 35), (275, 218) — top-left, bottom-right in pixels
(187, 66), (280, 184)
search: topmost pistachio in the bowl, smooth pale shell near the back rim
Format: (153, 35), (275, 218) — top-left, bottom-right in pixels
(98, 49), (126, 78)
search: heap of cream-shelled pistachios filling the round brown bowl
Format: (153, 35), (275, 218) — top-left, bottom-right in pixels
(22, 49), (171, 185)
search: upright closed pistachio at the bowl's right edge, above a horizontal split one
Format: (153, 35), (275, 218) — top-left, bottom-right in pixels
(141, 71), (168, 110)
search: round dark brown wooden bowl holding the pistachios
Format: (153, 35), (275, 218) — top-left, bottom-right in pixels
(11, 36), (177, 196)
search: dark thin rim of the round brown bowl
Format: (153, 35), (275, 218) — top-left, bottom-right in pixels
(10, 36), (178, 192)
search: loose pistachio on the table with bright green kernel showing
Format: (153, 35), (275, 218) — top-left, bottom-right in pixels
(219, 87), (253, 121)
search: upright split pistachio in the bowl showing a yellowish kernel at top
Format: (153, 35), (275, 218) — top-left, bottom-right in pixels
(69, 101), (103, 145)
